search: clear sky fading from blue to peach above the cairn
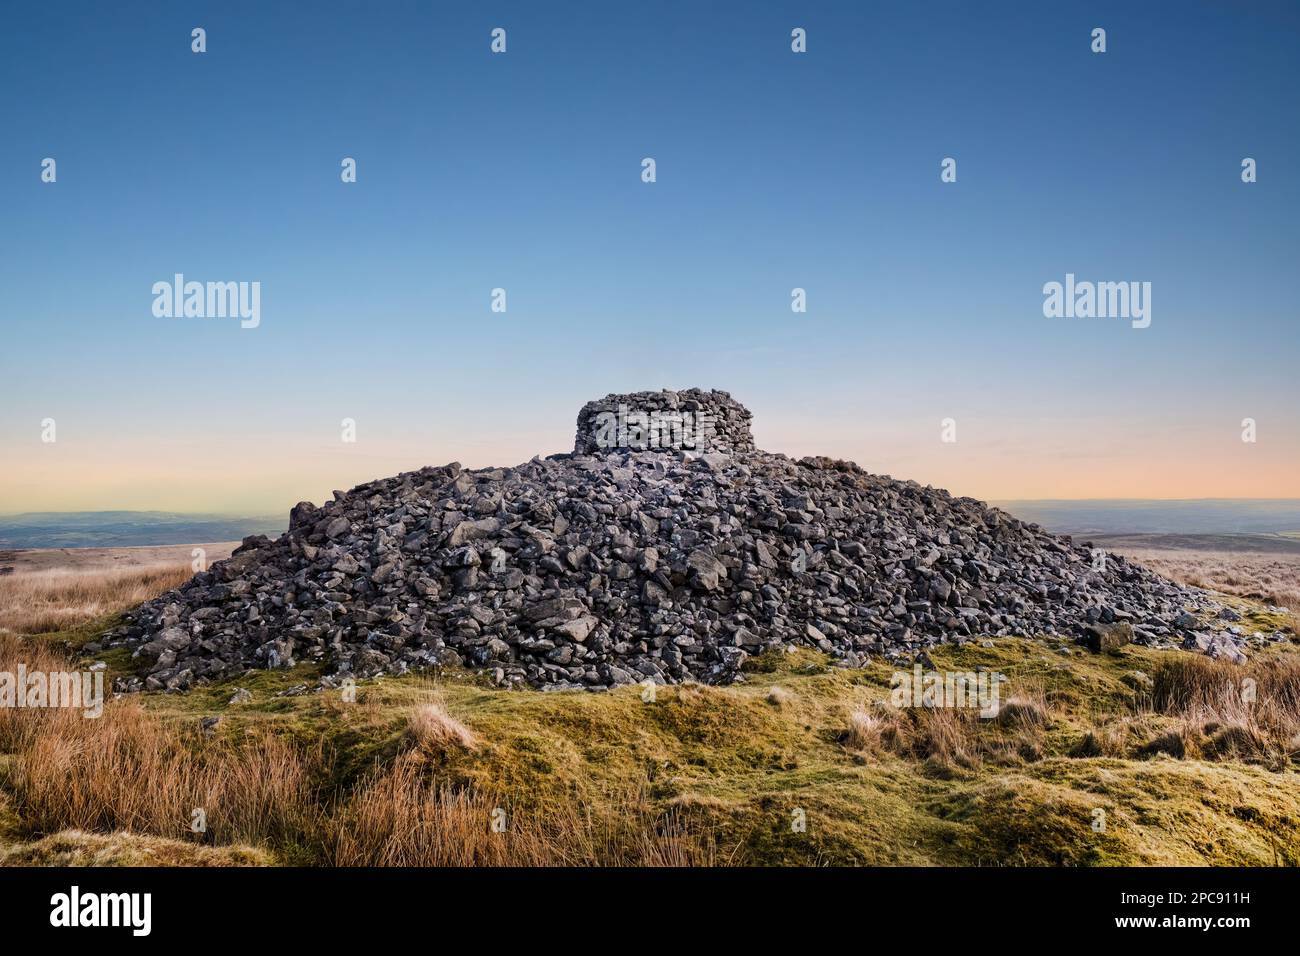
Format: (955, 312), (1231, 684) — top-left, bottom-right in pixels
(0, 0), (1300, 512)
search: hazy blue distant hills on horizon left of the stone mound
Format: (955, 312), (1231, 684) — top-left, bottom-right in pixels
(0, 511), (289, 549)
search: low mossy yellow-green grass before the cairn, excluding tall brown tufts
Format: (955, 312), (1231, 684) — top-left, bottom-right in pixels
(0, 613), (1300, 866)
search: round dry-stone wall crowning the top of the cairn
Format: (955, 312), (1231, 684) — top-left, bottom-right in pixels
(573, 389), (754, 455)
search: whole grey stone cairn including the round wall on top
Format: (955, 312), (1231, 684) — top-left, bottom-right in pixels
(109, 389), (1240, 689)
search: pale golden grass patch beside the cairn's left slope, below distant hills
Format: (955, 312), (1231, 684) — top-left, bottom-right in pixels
(0, 563), (194, 633)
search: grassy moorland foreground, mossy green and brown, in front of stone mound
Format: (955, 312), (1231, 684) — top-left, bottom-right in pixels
(0, 602), (1300, 865)
